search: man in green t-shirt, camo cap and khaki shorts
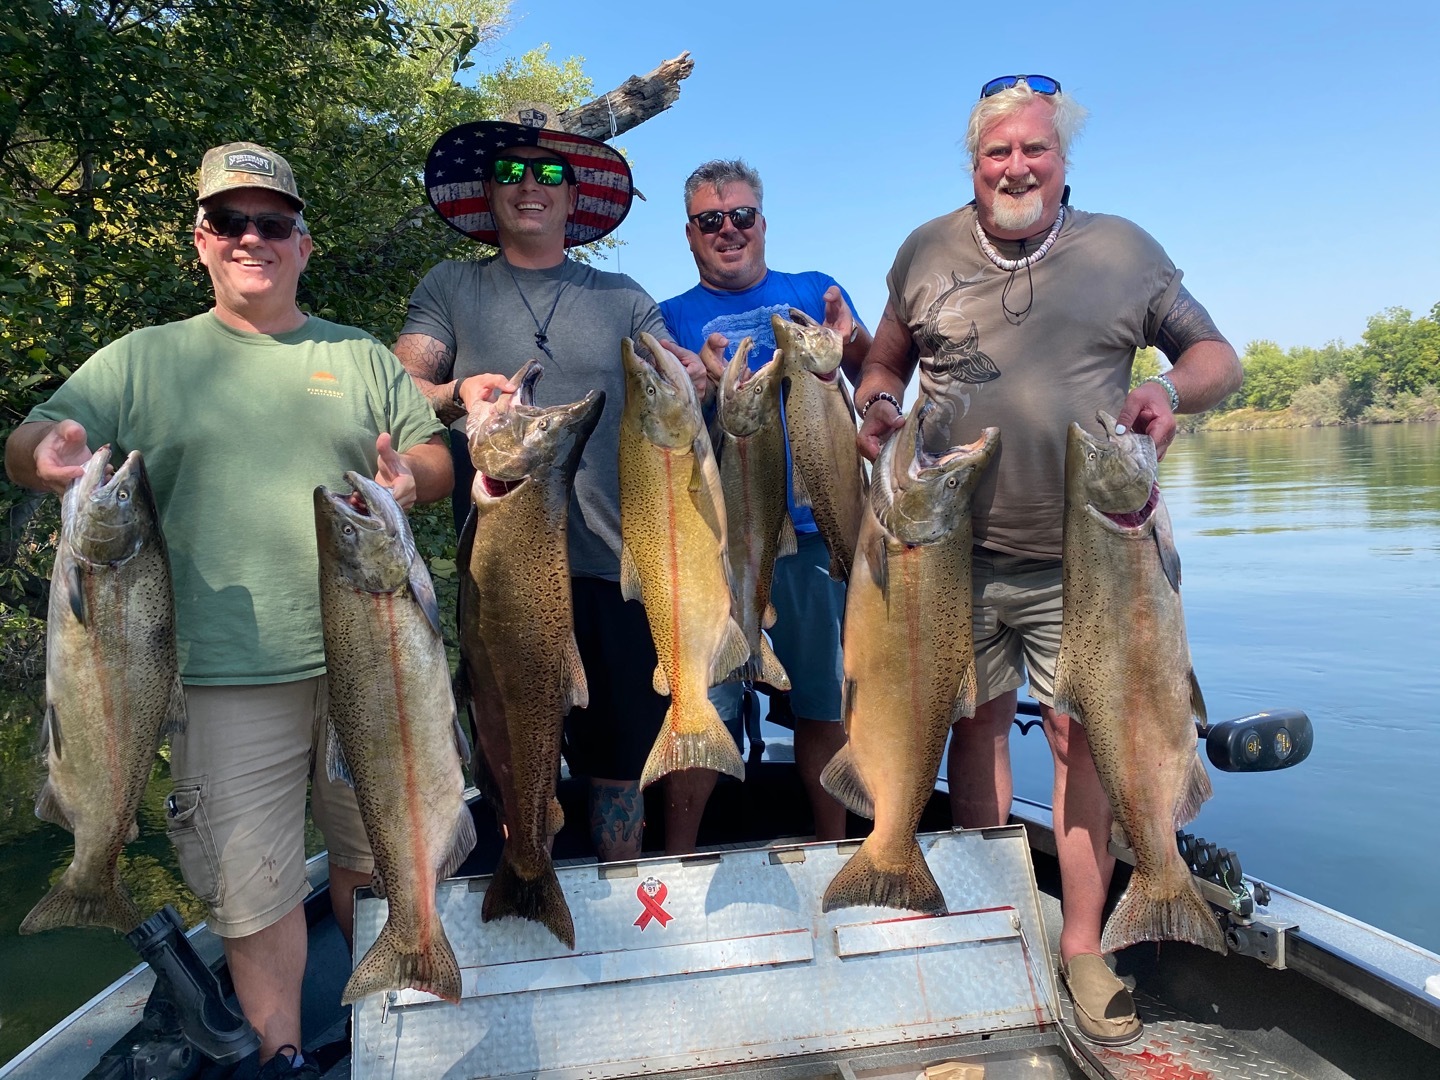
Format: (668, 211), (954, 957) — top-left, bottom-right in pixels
(6, 143), (452, 1076)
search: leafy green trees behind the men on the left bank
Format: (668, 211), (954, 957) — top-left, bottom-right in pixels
(0, 0), (590, 676)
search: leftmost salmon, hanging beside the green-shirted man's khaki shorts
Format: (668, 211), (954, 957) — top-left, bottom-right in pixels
(20, 446), (184, 933)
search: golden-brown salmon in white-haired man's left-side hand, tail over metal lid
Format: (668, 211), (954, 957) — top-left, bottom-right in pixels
(821, 402), (999, 914)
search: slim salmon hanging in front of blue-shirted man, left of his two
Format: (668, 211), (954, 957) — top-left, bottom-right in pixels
(717, 338), (795, 690)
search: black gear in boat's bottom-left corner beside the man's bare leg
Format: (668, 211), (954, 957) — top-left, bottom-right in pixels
(88, 904), (261, 1080)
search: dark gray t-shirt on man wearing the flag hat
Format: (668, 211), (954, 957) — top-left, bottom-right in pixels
(400, 256), (670, 582)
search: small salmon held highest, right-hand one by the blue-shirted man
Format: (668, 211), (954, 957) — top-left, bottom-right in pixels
(770, 308), (865, 582)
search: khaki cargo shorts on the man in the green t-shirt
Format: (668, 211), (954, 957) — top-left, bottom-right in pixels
(167, 675), (374, 937)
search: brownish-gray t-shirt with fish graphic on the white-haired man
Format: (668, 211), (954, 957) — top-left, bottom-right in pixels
(886, 204), (1181, 559)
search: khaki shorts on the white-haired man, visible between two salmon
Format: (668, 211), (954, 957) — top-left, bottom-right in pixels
(972, 547), (1061, 706)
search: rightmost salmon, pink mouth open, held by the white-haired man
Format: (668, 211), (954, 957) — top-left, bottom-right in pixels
(1056, 412), (1225, 953)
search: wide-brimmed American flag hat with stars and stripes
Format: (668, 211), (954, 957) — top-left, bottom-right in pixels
(425, 105), (635, 248)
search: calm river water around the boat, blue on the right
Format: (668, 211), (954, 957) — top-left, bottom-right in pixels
(0, 423), (1440, 1063)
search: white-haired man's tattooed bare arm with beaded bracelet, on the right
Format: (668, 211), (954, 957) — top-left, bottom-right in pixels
(1116, 288), (1244, 458)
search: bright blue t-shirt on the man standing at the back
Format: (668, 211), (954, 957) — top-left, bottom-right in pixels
(660, 271), (860, 533)
